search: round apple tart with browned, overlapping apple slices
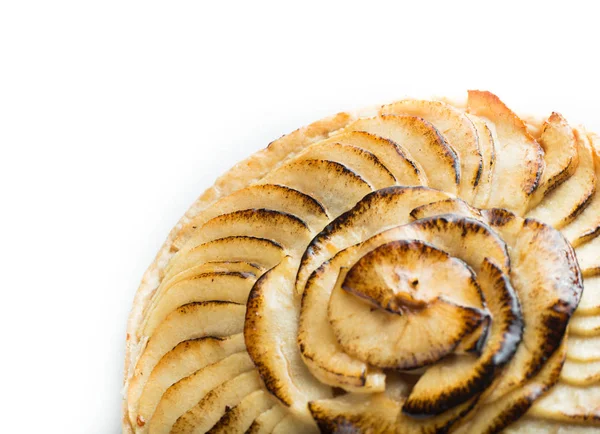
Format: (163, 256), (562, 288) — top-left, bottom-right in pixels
(123, 91), (600, 434)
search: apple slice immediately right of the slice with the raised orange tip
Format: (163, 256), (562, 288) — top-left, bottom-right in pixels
(529, 113), (579, 207)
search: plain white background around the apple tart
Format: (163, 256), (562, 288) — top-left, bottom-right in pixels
(0, 0), (600, 433)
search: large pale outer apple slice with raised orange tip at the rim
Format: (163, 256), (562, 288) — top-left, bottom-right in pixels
(467, 91), (544, 215)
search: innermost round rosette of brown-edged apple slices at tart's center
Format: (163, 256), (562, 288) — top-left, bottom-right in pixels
(328, 240), (489, 370)
